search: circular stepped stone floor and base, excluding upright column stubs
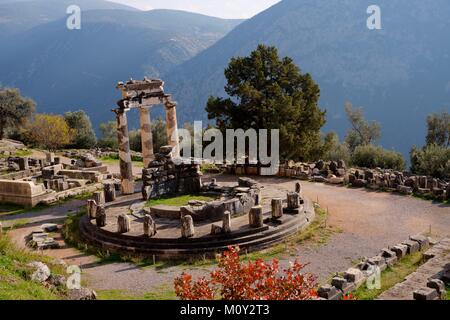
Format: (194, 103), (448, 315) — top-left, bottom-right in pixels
(80, 179), (315, 258)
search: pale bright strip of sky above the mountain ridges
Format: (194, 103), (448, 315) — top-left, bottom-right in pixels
(108, 0), (280, 19)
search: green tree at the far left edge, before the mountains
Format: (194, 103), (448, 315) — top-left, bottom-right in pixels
(0, 87), (36, 140)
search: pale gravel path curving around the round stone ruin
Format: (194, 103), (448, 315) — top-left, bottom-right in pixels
(2, 176), (450, 294)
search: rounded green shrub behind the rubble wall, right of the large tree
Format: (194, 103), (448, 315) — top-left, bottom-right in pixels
(351, 145), (405, 171)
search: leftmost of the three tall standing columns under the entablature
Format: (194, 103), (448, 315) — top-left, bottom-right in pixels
(116, 110), (134, 195)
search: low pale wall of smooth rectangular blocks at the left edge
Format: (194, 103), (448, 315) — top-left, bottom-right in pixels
(0, 180), (52, 207)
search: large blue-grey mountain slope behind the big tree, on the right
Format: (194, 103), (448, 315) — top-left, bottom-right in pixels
(165, 0), (450, 154)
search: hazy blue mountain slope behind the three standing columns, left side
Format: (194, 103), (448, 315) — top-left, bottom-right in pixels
(0, 10), (240, 125)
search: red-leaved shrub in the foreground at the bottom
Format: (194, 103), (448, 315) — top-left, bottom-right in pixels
(174, 247), (317, 300)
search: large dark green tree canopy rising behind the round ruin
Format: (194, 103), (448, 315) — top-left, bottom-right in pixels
(206, 45), (325, 160)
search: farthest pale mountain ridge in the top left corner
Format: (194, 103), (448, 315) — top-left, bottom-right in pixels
(0, 0), (137, 39)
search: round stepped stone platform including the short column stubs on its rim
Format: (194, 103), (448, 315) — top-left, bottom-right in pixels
(80, 179), (315, 258)
